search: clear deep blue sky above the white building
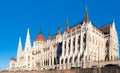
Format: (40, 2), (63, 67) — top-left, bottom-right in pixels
(0, 0), (120, 69)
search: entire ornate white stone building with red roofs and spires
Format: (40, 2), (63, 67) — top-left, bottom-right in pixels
(9, 10), (118, 71)
